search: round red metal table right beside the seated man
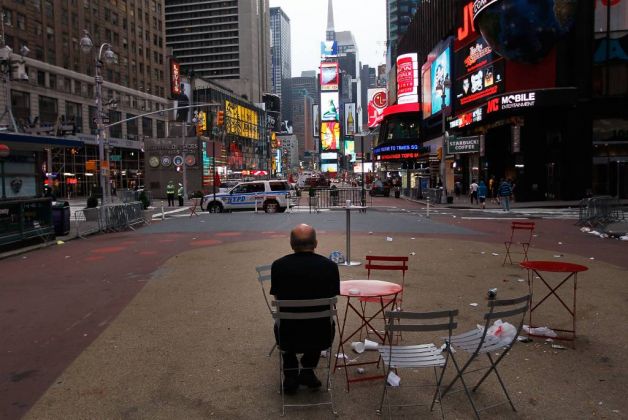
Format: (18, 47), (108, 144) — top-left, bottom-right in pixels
(334, 280), (402, 391)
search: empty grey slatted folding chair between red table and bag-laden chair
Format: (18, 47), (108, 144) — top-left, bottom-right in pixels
(377, 310), (458, 418)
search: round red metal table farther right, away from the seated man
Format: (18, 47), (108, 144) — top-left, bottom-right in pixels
(520, 261), (589, 341)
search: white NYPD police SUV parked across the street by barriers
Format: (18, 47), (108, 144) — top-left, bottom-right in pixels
(201, 180), (290, 213)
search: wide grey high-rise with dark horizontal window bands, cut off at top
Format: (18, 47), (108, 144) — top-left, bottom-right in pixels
(166, 0), (271, 102)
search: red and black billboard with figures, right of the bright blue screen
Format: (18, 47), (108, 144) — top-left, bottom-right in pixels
(453, 37), (504, 109)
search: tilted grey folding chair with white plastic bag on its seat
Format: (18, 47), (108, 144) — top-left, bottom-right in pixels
(443, 295), (530, 419)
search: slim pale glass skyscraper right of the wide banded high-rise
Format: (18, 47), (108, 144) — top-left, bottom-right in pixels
(270, 7), (292, 104)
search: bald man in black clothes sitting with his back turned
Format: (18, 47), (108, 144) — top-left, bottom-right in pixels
(270, 224), (340, 394)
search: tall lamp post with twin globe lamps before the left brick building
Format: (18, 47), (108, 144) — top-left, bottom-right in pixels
(80, 30), (115, 204)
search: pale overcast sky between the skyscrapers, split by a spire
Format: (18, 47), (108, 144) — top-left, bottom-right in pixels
(270, 0), (386, 77)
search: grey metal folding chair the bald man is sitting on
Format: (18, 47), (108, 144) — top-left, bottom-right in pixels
(272, 297), (337, 416)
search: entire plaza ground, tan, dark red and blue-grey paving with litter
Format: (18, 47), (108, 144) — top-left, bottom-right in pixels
(0, 199), (628, 419)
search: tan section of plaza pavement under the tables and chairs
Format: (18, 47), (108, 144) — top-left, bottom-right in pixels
(26, 233), (628, 419)
